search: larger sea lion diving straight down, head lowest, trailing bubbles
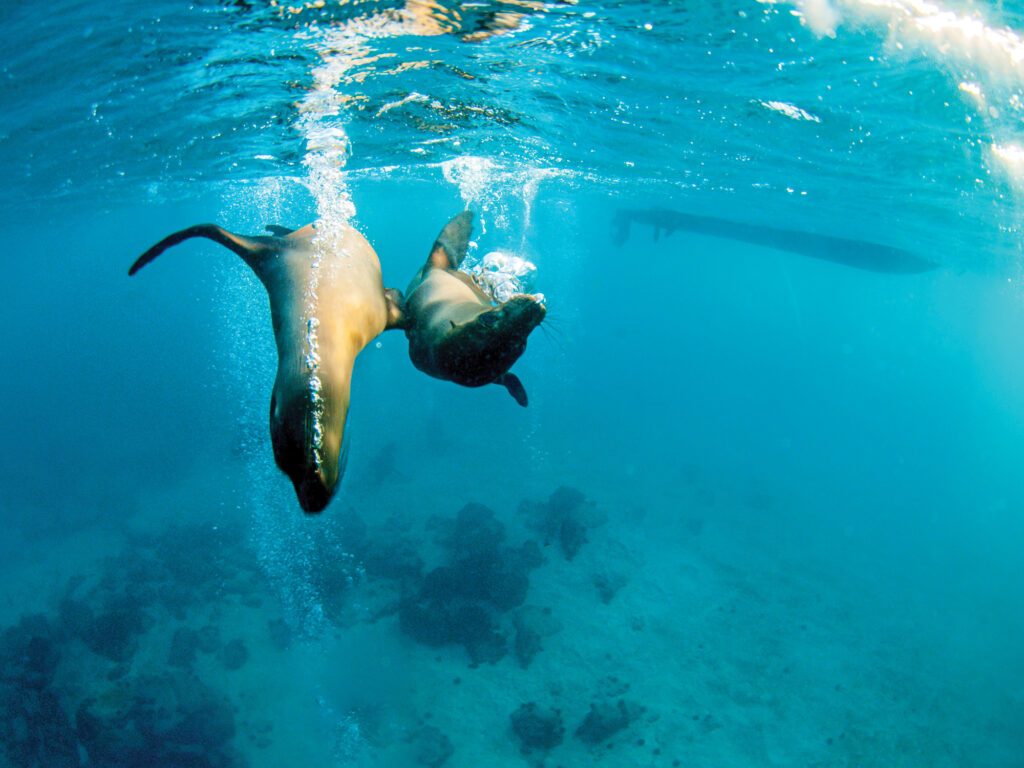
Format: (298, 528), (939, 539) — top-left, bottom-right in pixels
(128, 219), (402, 512)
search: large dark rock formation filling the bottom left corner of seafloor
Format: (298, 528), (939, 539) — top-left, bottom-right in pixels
(0, 525), (262, 768)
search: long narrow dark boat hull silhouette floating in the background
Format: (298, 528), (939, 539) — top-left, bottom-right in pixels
(611, 208), (938, 274)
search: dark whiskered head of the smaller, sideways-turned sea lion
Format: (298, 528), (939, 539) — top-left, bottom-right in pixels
(439, 294), (547, 387)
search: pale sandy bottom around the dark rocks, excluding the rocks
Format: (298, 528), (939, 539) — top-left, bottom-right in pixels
(0, 448), (1024, 768)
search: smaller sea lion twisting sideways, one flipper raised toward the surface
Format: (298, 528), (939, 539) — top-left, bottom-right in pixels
(404, 211), (546, 406)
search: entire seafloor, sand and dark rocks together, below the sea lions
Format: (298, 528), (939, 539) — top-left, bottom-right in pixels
(0, 428), (1011, 768)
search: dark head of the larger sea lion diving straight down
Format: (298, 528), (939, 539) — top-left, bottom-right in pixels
(270, 390), (348, 512)
